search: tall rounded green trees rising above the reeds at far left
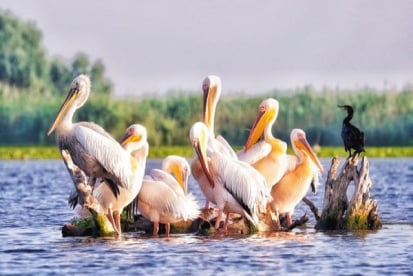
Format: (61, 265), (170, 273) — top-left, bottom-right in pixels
(0, 9), (112, 95)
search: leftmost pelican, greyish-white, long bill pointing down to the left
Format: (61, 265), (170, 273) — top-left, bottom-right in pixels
(47, 75), (133, 204)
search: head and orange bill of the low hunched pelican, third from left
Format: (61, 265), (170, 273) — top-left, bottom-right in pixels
(162, 155), (191, 194)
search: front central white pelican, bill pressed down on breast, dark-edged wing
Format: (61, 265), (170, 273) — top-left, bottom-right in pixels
(190, 122), (269, 230)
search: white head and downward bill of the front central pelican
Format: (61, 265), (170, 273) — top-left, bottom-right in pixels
(189, 122), (215, 187)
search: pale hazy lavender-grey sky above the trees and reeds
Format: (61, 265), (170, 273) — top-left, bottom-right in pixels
(0, 0), (413, 95)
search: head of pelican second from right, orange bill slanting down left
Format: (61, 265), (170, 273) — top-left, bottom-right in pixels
(245, 98), (279, 150)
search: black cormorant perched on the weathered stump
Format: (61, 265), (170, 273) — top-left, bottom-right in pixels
(338, 105), (365, 157)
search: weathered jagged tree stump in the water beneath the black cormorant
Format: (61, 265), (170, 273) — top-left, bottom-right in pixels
(316, 156), (381, 230)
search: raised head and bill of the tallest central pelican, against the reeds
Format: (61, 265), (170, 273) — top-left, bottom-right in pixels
(202, 75), (221, 133)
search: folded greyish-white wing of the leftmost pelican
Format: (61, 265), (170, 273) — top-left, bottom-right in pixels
(74, 125), (131, 186)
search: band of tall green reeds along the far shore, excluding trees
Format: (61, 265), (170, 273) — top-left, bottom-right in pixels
(0, 86), (413, 150)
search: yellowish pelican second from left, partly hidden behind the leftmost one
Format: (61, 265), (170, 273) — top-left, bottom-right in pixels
(77, 124), (149, 235)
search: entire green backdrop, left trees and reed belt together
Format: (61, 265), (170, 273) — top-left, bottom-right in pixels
(0, 10), (413, 146)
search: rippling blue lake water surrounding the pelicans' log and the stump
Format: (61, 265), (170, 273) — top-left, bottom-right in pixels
(0, 158), (413, 275)
